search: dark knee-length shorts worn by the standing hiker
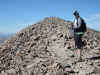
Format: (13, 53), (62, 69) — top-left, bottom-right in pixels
(74, 33), (83, 49)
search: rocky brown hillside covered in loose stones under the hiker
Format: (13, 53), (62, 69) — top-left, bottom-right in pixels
(0, 17), (100, 75)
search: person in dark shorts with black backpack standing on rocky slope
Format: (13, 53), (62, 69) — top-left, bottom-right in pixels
(72, 11), (86, 60)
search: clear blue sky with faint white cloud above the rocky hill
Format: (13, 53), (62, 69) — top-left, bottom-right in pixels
(0, 0), (100, 33)
